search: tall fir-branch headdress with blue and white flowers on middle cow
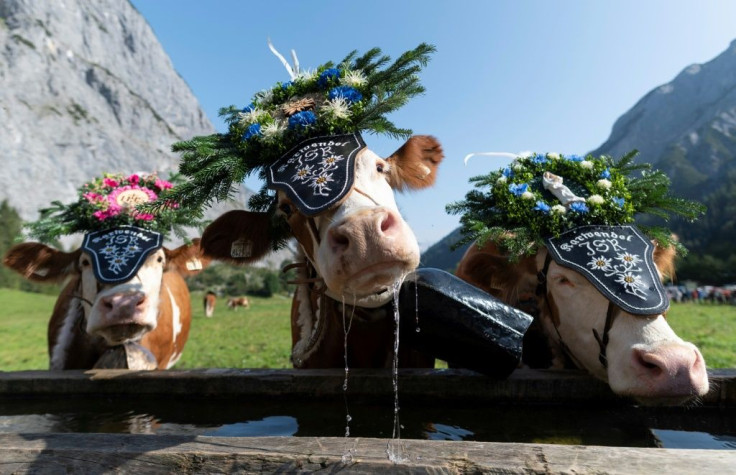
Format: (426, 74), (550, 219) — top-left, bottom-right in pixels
(152, 44), (435, 247)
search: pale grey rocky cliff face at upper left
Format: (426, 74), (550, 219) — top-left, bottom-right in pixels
(0, 0), (214, 219)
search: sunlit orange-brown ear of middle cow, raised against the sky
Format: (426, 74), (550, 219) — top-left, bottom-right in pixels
(387, 135), (444, 190)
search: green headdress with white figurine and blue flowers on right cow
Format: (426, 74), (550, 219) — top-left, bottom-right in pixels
(447, 151), (705, 259)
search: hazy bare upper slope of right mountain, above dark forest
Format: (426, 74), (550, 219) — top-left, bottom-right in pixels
(592, 41), (736, 199)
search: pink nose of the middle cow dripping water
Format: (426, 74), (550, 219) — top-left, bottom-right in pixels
(327, 209), (400, 255)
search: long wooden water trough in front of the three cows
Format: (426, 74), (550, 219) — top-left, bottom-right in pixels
(0, 369), (736, 473)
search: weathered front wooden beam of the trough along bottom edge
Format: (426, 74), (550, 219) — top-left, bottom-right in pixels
(0, 434), (736, 475)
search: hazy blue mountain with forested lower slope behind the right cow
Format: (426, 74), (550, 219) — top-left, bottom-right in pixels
(422, 40), (736, 283)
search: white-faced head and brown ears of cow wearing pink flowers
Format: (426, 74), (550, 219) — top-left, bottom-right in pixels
(3, 240), (206, 358)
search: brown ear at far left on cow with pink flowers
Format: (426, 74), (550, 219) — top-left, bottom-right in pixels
(3, 242), (82, 283)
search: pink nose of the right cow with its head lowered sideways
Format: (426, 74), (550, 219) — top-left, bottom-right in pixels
(633, 345), (708, 397)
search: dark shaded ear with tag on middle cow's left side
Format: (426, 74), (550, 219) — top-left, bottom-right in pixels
(200, 210), (271, 265)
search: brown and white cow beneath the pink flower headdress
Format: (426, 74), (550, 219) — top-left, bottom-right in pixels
(3, 240), (207, 370)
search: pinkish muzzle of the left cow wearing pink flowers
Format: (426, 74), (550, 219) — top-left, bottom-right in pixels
(87, 290), (156, 345)
